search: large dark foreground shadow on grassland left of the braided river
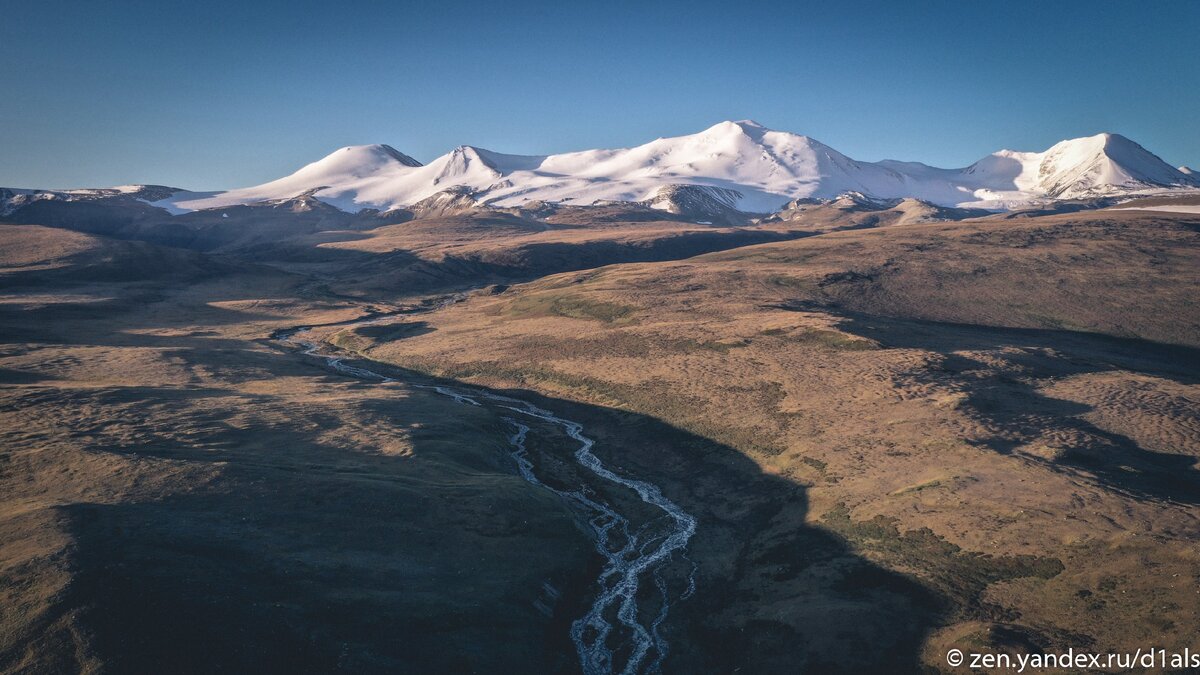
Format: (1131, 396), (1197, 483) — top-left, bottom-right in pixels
(44, 372), (590, 674)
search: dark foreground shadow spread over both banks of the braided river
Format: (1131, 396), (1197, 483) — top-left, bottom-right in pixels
(44, 350), (948, 673)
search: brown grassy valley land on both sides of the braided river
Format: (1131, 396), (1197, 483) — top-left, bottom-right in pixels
(0, 207), (1200, 673)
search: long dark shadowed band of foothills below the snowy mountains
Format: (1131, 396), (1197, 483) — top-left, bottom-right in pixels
(2, 198), (814, 298)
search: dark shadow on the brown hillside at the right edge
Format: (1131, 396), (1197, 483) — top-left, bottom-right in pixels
(839, 313), (1200, 504)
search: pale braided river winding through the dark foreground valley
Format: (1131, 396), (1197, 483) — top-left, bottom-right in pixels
(278, 319), (696, 675)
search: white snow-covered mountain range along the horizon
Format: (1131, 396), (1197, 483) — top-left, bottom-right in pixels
(32, 120), (1200, 213)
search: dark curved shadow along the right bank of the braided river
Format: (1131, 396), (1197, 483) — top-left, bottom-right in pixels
(292, 353), (1080, 673)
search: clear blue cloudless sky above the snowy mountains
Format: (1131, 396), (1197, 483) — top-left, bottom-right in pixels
(0, 0), (1200, 190)
